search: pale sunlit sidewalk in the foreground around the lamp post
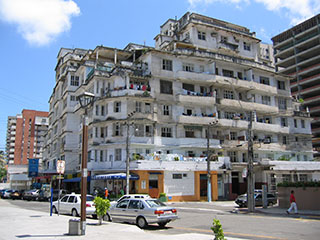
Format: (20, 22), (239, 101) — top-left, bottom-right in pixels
(0, 200), (243, 240)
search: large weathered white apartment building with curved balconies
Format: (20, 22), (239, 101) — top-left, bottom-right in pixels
(46, 13), (314, 200)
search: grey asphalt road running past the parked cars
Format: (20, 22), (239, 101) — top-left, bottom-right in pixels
(7, 200), (320, 240)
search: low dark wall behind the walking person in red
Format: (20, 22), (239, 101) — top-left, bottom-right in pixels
(278, 187), (320, 211)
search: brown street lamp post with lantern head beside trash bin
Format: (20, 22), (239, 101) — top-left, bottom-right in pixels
(78, 92), (94, 235)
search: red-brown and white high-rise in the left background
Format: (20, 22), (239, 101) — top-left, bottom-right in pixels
(6, 109), (48, 189)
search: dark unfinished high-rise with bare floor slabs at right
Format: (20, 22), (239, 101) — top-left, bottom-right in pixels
(272, 14), (320, 158)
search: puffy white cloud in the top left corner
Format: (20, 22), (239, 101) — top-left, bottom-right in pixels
(0, 0), (80, 45)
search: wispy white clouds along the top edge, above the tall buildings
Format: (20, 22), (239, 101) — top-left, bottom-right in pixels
(188, 0), (320, 25)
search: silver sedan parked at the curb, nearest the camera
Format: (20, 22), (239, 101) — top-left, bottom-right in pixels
(105, 198), (178, 228)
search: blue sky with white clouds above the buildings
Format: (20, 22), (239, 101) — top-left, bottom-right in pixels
(0, 0), (320, 153)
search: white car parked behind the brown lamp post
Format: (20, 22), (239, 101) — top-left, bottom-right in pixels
(52, 193), (96, 217)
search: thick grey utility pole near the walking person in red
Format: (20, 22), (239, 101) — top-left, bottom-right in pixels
(247, 111), (255, 212)
